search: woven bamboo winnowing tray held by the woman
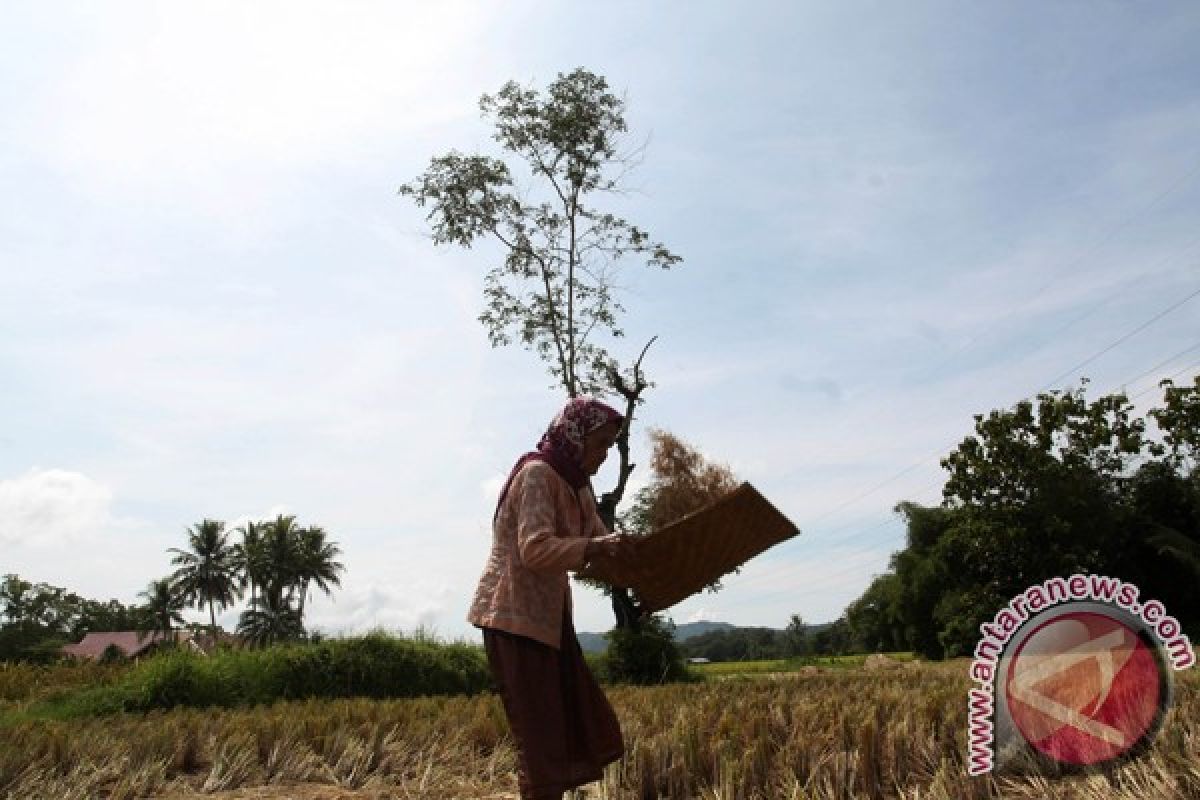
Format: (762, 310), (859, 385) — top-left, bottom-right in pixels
(580, 483), (800, 612)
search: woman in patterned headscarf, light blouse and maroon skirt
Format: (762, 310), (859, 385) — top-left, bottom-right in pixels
(467, 397), (629, 800)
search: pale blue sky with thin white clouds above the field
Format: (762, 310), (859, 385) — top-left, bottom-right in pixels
(0, 0), (1200, 640)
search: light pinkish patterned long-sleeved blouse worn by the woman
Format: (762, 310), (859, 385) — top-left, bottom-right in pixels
(467, 461), (608, 649)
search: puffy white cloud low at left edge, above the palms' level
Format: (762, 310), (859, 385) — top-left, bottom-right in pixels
(0, 468), (113, 548)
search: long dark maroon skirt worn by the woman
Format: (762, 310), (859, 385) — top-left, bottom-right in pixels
(484, 609), (625, 800)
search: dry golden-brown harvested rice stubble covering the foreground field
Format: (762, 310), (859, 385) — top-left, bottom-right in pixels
(0, 662), (1200, 800)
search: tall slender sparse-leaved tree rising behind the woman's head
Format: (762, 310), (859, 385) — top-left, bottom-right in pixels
(400, 68), (682, 625)
